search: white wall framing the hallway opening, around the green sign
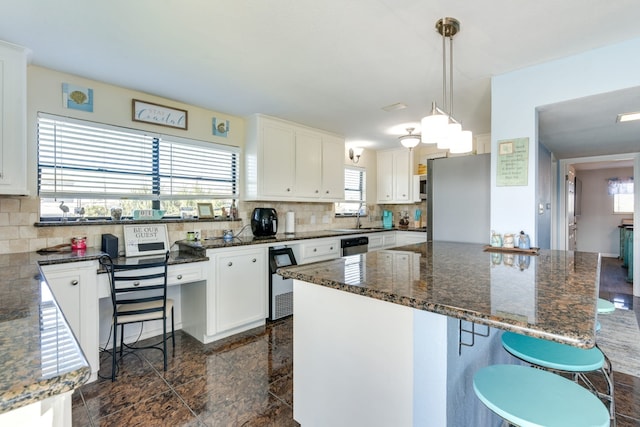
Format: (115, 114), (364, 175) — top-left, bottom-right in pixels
(491, 38), (640, 296)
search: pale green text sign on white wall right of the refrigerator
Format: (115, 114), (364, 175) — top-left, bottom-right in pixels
(496, 138), (529, 187)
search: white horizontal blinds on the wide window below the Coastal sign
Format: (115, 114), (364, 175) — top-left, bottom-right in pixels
(38, 113), (240, 200)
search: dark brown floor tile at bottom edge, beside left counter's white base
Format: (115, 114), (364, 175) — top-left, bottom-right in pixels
(94, 391), (202, 427)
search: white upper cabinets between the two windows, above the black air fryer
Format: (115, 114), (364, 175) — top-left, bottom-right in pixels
(244, 114), (344, 202)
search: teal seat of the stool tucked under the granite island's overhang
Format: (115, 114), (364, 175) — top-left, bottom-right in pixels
(502, 332), (604, 372)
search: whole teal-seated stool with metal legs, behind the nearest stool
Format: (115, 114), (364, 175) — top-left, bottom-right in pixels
(502, 332), (616, 425)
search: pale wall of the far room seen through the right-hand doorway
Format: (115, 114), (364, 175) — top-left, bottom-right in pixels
(576, 168), (633, 257)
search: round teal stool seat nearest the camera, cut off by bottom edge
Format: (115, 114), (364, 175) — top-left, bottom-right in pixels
(473, 365), (609, 427)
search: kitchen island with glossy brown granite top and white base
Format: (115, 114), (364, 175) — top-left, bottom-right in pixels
(278, 242), (600, 426)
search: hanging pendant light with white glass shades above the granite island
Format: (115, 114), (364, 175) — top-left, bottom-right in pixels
(421, 18), (473, 153)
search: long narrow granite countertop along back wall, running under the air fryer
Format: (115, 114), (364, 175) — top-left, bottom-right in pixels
(176, 227), (427, 251)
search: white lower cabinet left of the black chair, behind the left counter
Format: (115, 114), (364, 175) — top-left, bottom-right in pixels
(41, 261), (100, 381)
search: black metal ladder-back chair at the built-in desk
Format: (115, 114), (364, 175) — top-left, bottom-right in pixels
(100, 252), (176, 381)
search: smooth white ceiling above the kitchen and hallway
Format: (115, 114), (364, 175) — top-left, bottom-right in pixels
(0, 0), (640, 158)
